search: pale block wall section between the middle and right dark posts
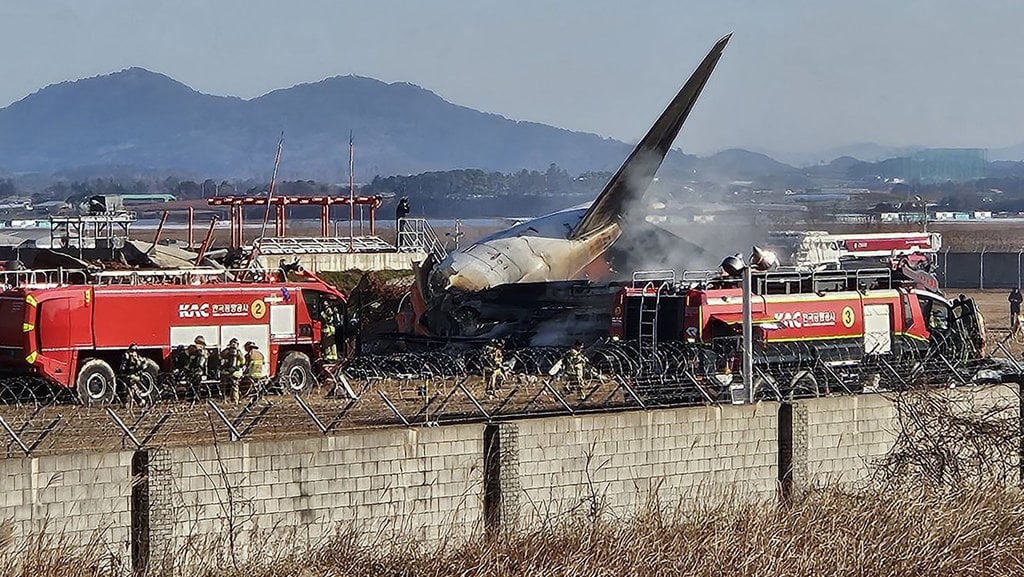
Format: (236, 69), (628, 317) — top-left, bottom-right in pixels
(502, 403), (778, 524)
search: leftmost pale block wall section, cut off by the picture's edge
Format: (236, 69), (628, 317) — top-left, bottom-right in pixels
(0, 452), (132, 555)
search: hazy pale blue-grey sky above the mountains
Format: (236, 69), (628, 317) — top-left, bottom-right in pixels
(0, 0), (1024, 154)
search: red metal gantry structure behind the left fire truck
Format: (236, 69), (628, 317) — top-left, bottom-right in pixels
(207, 196), (383, 247)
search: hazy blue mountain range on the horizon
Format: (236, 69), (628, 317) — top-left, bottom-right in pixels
(0, 68), (1024, 183)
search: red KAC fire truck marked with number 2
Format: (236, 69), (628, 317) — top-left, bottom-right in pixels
(0, 270), (345, 403)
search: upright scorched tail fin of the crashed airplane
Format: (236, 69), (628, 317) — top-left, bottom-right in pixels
(569, 34), (732, 239)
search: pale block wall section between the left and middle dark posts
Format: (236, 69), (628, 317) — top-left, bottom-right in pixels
(151, 425), (483, 565)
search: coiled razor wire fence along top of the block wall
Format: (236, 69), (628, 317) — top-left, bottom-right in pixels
(0, 338), (1022, 456)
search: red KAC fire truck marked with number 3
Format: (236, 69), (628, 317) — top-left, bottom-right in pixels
(611, 269), (984, 397)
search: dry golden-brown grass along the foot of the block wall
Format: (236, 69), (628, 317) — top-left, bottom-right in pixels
(5, 487), (1024, 577)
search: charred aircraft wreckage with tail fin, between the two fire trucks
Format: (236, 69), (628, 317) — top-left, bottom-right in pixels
(411, 35), (731, 345)
